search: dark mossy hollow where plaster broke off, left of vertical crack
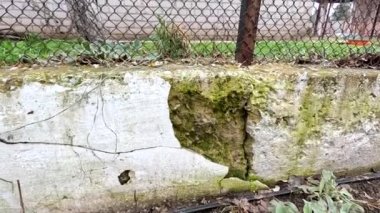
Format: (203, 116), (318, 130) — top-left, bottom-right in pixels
(169, 74), (271, 179)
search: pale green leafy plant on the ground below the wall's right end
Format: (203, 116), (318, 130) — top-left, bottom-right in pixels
(271, 171), (364, 213)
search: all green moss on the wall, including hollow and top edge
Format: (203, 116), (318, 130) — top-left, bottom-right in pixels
(0, 65), (380, 183)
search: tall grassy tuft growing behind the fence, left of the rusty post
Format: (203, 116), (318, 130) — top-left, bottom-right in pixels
(152, 18), (190, 58)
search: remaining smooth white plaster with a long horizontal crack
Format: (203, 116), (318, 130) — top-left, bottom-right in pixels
(0, 70), (228, 212)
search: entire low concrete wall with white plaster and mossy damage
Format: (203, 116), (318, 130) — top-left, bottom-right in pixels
(0, 65), (380, 211)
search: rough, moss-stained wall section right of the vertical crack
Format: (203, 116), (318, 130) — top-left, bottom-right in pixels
(247, 70), (380, 180)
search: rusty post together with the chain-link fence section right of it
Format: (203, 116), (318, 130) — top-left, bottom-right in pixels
(236, 0), (380, 68)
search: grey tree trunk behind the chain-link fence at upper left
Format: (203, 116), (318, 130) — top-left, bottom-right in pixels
(66, 0), (104, 42)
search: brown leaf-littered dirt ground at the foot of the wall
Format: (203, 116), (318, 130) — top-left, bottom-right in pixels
(117, 179), (380, 213)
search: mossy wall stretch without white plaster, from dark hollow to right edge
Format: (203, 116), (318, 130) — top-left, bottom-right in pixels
(169, 64), (380, 184)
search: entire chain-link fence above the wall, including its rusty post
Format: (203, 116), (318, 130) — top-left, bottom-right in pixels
(0, 0), (380, 66)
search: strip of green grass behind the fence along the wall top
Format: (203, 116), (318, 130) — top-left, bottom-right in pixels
(0, 35), (380, 64)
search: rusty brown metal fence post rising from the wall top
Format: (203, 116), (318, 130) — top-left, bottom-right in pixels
(235, 0), (261, 66)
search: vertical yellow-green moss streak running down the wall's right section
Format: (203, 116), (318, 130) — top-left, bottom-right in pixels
(287, 76), (337, 176)
